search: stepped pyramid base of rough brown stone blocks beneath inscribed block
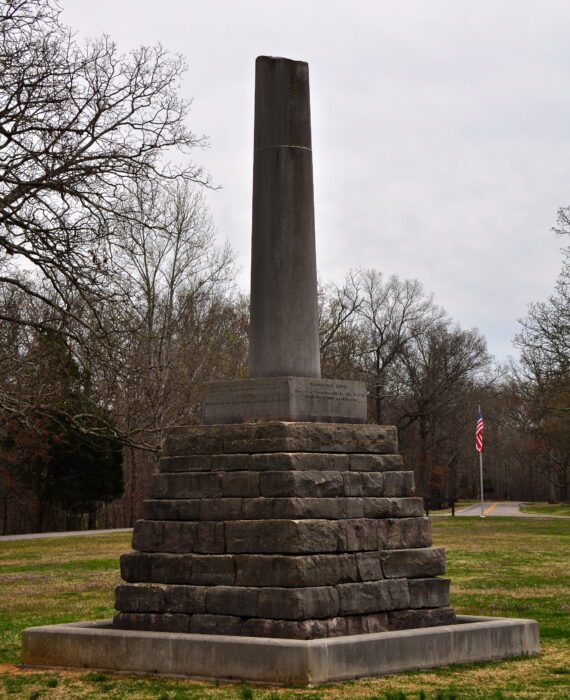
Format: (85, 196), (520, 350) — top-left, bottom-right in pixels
(114, 418), (455, 639)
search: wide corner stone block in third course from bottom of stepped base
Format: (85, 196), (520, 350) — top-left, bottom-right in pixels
(235, 554), (357, 587)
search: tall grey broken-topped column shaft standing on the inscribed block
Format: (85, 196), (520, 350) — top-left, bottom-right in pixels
(249, 56), (321, 378)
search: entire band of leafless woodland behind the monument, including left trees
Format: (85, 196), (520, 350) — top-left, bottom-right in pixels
(0, 0), (570, 534)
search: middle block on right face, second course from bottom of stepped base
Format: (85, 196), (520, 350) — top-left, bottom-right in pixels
(337, 579), (410, 615)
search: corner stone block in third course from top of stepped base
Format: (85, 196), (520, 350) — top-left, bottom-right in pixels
(260, 471), (345, 498)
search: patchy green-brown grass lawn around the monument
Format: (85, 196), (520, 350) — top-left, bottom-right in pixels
(0, 518), (570, 700)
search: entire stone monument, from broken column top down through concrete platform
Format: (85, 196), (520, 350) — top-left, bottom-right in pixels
(24, 57), (538, 683)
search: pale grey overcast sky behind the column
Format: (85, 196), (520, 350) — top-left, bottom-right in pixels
(62, 0), (570, 360)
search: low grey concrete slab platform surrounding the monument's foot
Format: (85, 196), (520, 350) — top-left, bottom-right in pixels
(23, 615), (539, 685)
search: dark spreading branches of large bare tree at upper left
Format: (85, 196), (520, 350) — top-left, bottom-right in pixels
(0, 0), (206, 336)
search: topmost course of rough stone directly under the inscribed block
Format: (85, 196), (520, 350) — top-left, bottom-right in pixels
(163, 421), (398, 457)
